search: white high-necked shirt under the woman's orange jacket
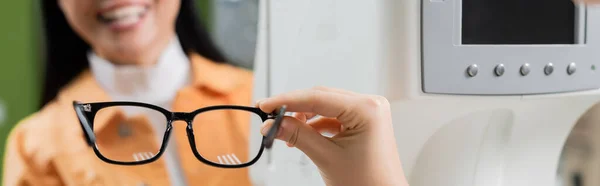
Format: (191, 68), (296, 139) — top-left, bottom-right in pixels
(88, 37), (192, 186)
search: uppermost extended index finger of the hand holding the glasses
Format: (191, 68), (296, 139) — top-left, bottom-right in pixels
(259, 89), (357, 119)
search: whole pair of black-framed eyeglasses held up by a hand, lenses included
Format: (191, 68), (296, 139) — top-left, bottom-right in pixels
(73, 101), (286, 168)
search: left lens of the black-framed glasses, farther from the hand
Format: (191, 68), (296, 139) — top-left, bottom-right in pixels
(94, 106), (167, 162)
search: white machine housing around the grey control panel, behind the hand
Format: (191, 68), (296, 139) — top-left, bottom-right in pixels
(251, 0), (600, 186)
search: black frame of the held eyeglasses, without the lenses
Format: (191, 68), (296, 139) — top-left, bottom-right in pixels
(73, 101), (285, 168)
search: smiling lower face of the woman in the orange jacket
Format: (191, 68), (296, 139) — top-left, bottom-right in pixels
(57, 0), (181, 64)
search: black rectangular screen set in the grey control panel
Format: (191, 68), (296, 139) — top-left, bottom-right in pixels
(462, 0), (581, 44)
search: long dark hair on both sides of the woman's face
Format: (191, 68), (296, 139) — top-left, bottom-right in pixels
(41, 0), (226, 106)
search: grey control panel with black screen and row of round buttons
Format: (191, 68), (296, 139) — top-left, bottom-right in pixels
(421, 0), (600, 95)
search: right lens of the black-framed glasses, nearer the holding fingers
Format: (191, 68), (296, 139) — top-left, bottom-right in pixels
(193, 109), (262, 165)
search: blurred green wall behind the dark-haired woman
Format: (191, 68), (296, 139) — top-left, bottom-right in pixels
(0, 0), (212, 180)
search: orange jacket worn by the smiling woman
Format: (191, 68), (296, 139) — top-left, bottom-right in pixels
(3, 54), (252, 186)
